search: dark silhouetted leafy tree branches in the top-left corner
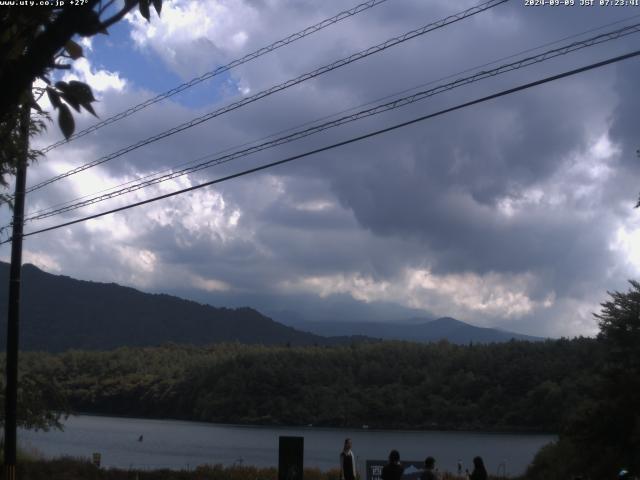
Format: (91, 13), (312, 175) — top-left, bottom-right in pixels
(0, 0), (162, 185)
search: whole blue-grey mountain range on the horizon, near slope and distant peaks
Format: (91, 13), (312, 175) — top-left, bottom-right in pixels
(0, 262), (537, 352)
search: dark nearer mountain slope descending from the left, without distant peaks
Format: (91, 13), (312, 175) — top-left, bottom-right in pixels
(0, 262), (342, 352)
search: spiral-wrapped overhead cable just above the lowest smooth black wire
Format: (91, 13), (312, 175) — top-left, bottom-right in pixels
(25, 23), (640, 222)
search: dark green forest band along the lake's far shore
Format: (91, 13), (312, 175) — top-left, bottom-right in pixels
(17, 339), (601, 431)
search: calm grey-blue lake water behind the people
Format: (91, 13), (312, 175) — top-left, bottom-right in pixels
(18, 415), (556, 475)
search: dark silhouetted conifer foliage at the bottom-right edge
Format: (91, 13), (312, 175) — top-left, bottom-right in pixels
(528, 281), (640, 479)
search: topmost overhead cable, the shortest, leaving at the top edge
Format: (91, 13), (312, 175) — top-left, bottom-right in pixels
(40, 0), (387, 153)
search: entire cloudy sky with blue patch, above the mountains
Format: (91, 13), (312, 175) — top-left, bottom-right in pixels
(0, 0), (640, 337)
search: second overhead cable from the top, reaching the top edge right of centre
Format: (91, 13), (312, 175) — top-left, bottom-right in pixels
(27, 0), (509, 193)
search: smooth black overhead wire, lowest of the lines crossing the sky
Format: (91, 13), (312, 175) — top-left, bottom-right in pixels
(6, 50), (640, 245)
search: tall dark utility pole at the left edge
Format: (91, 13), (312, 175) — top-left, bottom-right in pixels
(4, 102), (31, 480)
